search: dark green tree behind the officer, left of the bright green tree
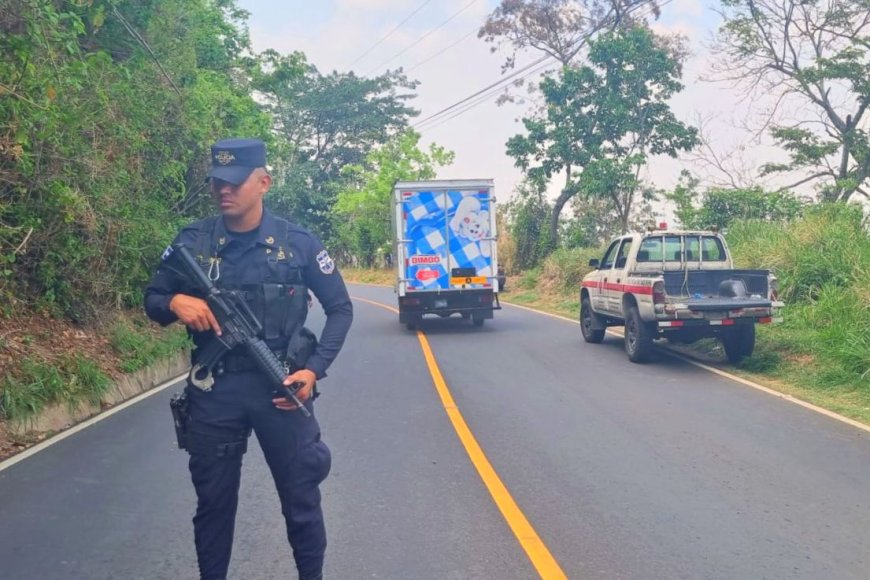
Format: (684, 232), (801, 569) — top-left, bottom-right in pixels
(254, 51), (417, 240)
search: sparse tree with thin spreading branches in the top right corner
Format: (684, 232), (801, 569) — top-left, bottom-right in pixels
(717, 0), (870, 201)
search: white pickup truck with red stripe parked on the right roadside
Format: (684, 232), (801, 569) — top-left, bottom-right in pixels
(580, 230), (783, 364)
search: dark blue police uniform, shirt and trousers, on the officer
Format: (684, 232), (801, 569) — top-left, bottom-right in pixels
(145, 210), (353, 579)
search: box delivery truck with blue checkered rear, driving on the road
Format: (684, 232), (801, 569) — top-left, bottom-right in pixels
(392, 179), (501, 329)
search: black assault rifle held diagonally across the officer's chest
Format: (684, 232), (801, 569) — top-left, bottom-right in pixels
(165, 244), (316, 417)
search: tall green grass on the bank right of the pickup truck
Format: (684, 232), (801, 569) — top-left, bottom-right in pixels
(728, 204), (870, 390)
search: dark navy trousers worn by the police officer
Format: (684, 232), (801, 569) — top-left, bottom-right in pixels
(187, 372), (331, 580)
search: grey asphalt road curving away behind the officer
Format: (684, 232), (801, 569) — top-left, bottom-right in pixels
(0, 286), (870, 580)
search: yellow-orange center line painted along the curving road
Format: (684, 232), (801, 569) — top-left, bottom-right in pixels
(353, 296), (567, 580)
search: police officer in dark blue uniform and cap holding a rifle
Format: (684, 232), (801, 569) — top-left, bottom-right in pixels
(145, 139), (353, 580)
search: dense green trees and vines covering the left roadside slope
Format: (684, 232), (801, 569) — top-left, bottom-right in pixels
(0, 0), (268, 320)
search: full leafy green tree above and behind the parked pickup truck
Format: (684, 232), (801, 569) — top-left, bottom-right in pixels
(507, 27), (697, 245)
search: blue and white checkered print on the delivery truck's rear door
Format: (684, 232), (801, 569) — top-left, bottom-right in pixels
(403, 191), (494, 290)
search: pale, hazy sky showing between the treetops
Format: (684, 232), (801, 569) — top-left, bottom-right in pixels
(238, 0), (804, 217)
